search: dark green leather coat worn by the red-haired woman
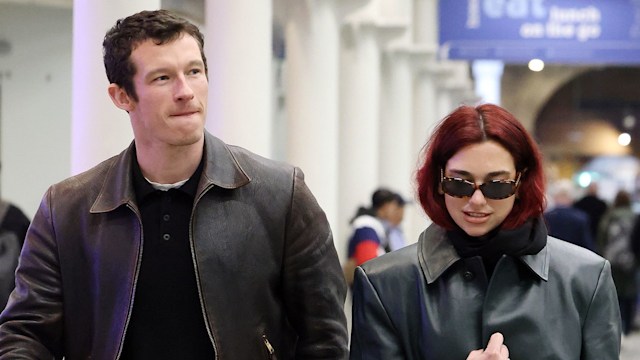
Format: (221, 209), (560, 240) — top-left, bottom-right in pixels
(351, 222), (621, 360)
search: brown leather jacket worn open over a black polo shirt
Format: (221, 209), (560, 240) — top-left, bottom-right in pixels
(0, 133), (348, 360)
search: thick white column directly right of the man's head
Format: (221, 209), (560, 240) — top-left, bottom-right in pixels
(205, 0), (273, 157)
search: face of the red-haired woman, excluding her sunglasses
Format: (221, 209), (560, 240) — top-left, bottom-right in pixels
(444, 141), (517, 236)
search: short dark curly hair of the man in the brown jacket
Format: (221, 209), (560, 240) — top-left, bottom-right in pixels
(102, 10), (207, 101)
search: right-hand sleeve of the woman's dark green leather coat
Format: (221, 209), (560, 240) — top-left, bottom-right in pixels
(580, 261), (622, 360)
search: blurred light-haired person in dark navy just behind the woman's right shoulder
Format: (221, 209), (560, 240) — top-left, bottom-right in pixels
(544, 179), (595, 251)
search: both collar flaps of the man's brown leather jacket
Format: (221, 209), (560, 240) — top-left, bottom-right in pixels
(91, 131), (251, 213)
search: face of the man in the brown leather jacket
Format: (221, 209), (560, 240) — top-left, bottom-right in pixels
(112, 35), (208, 149)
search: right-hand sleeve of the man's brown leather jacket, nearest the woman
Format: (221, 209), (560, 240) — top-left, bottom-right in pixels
(283, 168), (348, 360)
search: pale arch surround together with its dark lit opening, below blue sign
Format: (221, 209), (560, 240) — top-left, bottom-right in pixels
(503, 66), (640, 179)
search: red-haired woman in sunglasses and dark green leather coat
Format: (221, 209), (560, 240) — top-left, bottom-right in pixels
(351, 104), (620, 360)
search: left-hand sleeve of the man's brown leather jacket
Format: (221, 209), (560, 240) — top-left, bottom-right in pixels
(0, 190), (63, 359)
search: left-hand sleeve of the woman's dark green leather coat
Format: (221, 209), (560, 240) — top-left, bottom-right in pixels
(350, 267), (405, 360)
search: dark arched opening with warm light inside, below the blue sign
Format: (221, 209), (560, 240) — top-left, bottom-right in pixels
(535, 67), (640, 158)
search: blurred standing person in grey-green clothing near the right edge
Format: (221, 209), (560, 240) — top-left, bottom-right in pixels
(597, 190), (638, 335)
